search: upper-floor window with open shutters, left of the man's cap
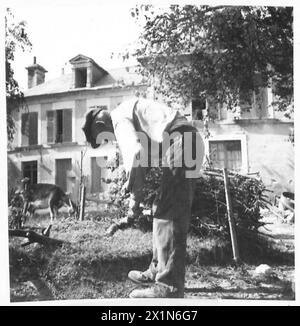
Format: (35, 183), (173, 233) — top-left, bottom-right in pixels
(47, 109), (72, 143)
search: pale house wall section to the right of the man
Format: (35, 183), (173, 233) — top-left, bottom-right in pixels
(190, 88), (294, 197)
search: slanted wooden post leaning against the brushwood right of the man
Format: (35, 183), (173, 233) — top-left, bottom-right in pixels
(223, 168), (240, 263)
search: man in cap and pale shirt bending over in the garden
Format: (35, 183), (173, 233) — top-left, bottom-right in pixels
(83, 98), (204, 298)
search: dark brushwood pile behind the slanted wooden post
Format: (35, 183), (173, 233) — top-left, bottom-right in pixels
(192, 172), (269, 235)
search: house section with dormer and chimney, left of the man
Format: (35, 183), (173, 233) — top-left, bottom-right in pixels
(8, 55), (145, 199)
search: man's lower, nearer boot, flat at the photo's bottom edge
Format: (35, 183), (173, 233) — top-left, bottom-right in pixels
(129, 283), (183, 299)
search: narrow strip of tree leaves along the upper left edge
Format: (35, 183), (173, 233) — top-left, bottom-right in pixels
(5, 8), (32, 142)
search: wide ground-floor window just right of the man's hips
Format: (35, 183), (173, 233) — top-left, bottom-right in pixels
(209, 140), (242, 172)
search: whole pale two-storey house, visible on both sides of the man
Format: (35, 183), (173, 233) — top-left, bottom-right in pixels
(8, 55), (294, 199)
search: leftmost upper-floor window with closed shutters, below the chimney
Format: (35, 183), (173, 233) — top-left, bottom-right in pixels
(21, 112), (38, 146)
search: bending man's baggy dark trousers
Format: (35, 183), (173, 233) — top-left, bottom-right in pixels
(130, 126), (204, 297)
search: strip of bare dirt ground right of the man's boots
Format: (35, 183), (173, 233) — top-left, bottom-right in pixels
(185, 265), (295, 300)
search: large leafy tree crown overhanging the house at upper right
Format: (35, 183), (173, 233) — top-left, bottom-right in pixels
(131, 5), (293, 119)
